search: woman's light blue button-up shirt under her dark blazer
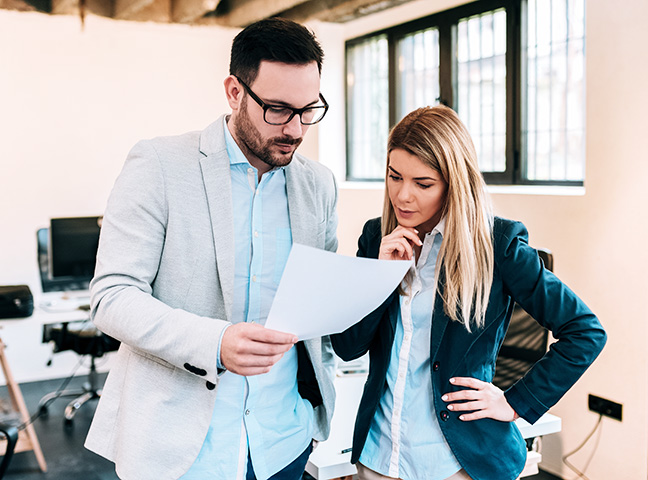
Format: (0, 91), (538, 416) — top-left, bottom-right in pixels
(359, 219), (461, 480)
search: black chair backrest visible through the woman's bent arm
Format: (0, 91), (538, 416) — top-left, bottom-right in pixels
(493, 249), (553, 390)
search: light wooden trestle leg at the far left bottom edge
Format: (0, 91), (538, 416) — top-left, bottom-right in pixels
(0, 339), (47, 472)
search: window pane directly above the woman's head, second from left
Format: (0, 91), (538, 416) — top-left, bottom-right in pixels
(396, 28), (439, 121)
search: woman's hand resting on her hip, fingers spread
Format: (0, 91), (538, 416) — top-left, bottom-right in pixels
(441, 377), (519, 422)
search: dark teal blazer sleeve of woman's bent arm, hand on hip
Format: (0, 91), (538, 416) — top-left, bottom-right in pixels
(494, 222), (606, 423)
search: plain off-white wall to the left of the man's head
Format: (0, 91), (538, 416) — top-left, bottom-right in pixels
(0, 10), (236, 290)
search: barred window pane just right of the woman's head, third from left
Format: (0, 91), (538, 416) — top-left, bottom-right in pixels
(455, 9), (506, 172)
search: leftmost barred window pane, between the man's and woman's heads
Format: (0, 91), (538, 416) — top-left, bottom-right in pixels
(346, 35), (389, 179)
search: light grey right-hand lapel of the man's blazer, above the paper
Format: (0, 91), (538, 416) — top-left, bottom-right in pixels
(285, 158), (317, 246)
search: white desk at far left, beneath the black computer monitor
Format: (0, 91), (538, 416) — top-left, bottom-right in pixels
(0, 296), (113, 383)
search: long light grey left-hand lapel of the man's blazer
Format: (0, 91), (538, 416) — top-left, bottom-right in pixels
(200, 117), (234, 320)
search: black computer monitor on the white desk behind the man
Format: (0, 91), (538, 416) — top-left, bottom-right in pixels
(43, 217), (102, 291)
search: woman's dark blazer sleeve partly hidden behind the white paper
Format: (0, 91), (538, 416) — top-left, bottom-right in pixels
(331, 218), (398, 361)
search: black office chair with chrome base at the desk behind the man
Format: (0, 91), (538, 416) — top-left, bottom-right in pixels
(36, 228), (119, 424)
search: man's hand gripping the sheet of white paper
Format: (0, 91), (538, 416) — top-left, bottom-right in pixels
(221, 323), (298, 376)
